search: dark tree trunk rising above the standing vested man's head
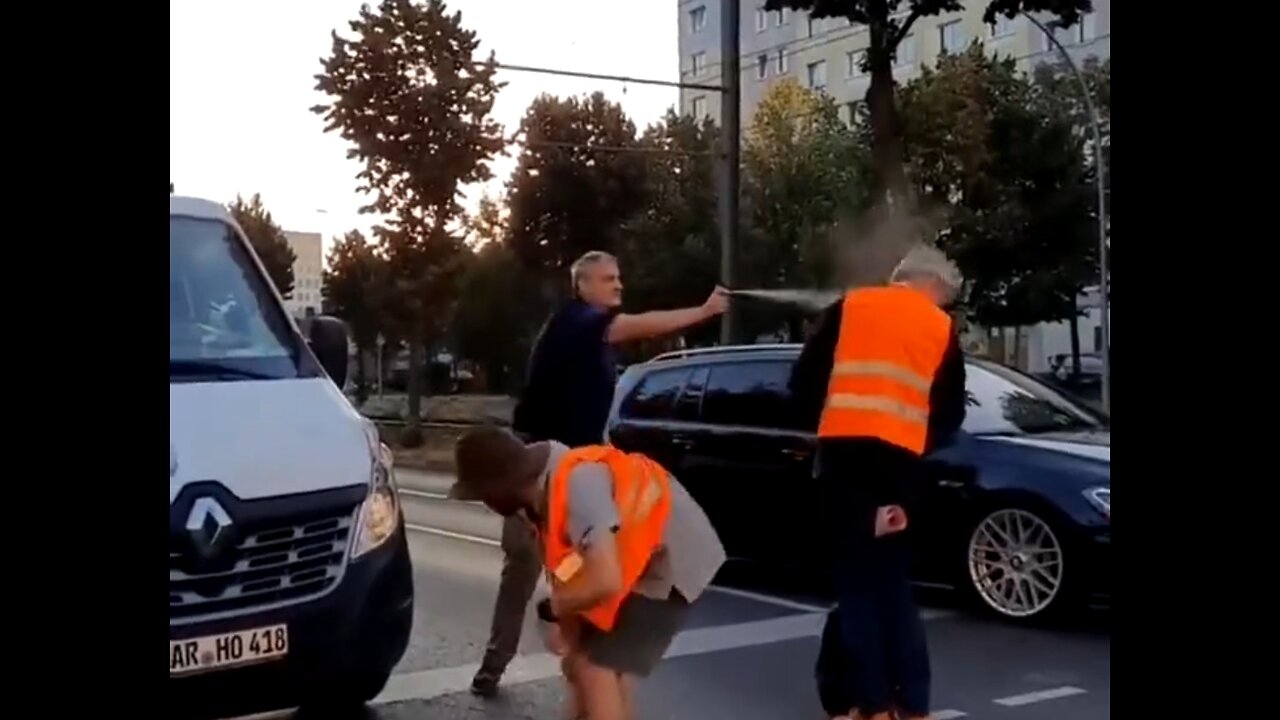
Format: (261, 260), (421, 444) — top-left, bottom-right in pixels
(867, 23), (910, 208)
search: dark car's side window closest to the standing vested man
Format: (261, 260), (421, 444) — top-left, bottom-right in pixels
(701, 360), (795, 429)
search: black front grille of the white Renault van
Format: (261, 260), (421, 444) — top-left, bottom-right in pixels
(169, 510), (355, 623)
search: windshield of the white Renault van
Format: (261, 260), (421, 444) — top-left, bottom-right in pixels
(169, 215), (315, 382)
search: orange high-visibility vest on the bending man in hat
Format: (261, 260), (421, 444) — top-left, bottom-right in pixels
(543, 445), (671, 630)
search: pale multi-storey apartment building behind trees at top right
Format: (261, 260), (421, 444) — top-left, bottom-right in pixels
(678, 0), (1111, 124)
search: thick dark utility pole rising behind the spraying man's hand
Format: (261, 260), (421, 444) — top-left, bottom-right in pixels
(721, 0), (742, 345)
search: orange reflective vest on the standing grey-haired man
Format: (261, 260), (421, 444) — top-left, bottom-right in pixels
(818, 286), (951, 455)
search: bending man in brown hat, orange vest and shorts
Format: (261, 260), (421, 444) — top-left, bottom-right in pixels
(449, 427), (724, 720)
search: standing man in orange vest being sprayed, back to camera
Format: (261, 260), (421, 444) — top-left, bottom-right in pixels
(791, 246), (965, 720)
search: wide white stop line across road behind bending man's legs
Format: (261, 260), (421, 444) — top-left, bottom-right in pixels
(376, 612), (826, 702)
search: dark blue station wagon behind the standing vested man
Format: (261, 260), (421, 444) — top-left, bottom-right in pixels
(608, 345), (1111, 619)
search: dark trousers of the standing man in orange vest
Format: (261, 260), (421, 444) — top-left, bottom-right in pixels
(819, 440), (931, 717)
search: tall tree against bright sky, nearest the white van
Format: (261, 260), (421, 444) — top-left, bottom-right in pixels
(312, 0), (504, 442)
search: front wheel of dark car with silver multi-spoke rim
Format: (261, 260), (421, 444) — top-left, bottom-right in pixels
(960, 503), (1079, 623)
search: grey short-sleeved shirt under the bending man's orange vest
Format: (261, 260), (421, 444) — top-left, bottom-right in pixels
(543, 442), (724, 602)
